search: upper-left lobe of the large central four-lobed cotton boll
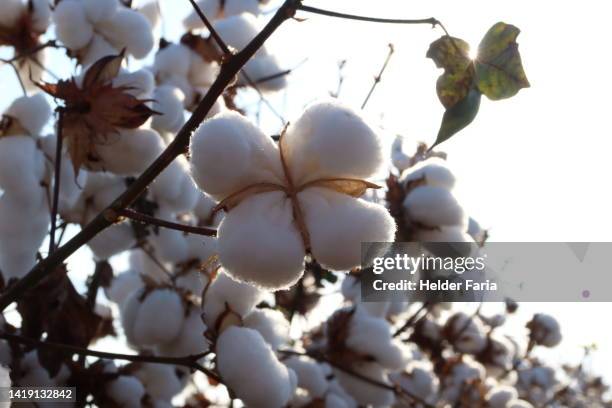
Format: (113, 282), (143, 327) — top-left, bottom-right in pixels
(191, 112), (284, 200)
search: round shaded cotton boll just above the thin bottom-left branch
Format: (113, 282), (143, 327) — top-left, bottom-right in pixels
(121, 289), (185, 345)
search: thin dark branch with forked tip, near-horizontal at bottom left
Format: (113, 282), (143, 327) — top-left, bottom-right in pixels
(0, 332), (221, 383)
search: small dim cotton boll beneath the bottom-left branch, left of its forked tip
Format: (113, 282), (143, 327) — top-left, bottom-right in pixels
(134, 363), (183, 401)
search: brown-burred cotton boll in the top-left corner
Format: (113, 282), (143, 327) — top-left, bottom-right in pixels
(0, 0), (51, 90)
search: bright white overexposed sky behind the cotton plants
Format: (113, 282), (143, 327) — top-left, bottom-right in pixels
(0, 0), (612, 384)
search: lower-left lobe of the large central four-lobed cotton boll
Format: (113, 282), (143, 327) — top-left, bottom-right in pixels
(218, 192), (306, 290)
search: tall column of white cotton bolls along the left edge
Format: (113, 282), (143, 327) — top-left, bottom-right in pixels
(0, 94), (51, 282)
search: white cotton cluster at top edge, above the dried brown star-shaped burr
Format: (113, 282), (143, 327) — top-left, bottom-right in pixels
(52, 0), (154, 66)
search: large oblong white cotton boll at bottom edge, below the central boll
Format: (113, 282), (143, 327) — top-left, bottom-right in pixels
(217, 326), (296, 408)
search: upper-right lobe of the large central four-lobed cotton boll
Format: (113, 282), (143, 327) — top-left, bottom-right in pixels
(284, 102), (383, 184)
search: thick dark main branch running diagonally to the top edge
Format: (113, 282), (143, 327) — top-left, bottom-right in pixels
(0, 0), (301, 311)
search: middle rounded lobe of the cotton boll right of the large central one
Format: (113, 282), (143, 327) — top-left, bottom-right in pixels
(403, 186), (467, 227)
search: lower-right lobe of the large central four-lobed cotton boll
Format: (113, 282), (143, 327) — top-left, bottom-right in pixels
(302, 188), (395, 271)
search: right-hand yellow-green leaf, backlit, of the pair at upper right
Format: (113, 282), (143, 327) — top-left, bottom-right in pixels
(475, 22), (529, 100)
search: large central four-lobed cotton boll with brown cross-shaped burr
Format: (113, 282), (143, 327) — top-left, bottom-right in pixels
(191, 102), (395, 290)
